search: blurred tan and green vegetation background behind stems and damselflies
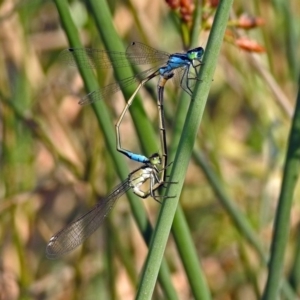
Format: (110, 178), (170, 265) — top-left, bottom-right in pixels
(0, 0), (300, 300)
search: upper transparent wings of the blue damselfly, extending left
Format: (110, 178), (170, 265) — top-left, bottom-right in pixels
(60, 42), (169, 69)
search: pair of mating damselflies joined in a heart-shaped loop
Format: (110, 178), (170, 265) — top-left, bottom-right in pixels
(46, 42), (204, 259)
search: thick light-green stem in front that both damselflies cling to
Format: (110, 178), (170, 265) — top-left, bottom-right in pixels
(136, 0), (233, 300)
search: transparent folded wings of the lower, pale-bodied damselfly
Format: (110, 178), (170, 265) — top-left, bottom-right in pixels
(46, 179), (130, 259)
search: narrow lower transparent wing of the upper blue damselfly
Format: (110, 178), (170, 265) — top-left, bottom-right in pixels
(79, 68), (157, 105)
